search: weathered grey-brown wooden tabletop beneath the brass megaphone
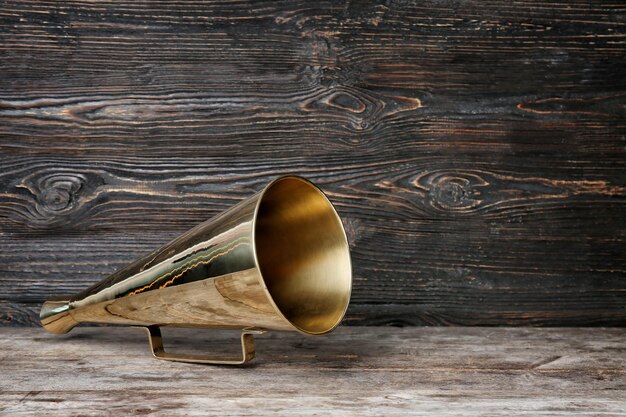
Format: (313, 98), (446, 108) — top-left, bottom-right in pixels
(0, 327), (626, 416)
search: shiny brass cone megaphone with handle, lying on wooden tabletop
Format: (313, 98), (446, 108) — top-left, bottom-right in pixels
(40, 176), (352, 364)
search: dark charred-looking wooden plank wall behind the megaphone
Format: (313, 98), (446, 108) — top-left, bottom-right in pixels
(0, 0), (626, 325)
